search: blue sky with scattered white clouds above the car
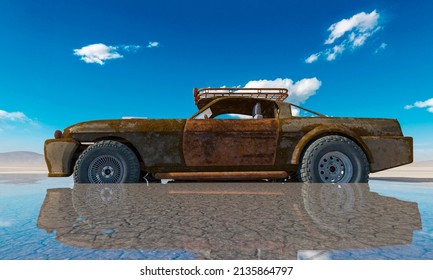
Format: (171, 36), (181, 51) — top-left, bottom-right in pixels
(0, 0), (433, 160)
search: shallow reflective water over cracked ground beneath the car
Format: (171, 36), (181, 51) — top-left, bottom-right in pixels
(0, 174), (433, 260)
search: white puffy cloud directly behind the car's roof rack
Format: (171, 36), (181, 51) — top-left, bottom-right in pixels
(244, 77), (322, 104)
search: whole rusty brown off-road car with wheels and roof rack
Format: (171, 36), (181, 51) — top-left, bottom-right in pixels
(44, 88), (413, 183)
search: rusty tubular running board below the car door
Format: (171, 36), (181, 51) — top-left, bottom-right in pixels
(155, 171), (289, 181)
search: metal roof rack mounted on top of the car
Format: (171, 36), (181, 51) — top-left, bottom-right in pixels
(193, 88), (289, 104)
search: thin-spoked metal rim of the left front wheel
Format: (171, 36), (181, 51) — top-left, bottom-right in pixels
(88, 155), (124, 183)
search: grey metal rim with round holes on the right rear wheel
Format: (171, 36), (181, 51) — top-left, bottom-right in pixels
(318, 151), (353, 183)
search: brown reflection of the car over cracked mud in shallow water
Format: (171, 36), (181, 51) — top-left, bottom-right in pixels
(38, 183), (421, 259)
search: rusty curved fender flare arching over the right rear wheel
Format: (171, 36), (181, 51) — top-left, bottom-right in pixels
(290, 125), (373, 165)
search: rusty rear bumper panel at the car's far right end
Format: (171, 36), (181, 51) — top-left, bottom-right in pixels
(362, 136), (413, 172)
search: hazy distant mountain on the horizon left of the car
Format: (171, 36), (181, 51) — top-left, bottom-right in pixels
(0, 151), (45, 168)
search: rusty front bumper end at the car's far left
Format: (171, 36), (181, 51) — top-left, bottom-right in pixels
(44, 138), (80, 177)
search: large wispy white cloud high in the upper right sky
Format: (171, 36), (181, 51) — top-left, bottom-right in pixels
(305, 10), (380, 63)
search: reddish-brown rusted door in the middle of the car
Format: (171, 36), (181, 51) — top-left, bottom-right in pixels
(183, 118), (279, 167)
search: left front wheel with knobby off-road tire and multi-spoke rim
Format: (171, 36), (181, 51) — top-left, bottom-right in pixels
(74, 140), (140, 184)
